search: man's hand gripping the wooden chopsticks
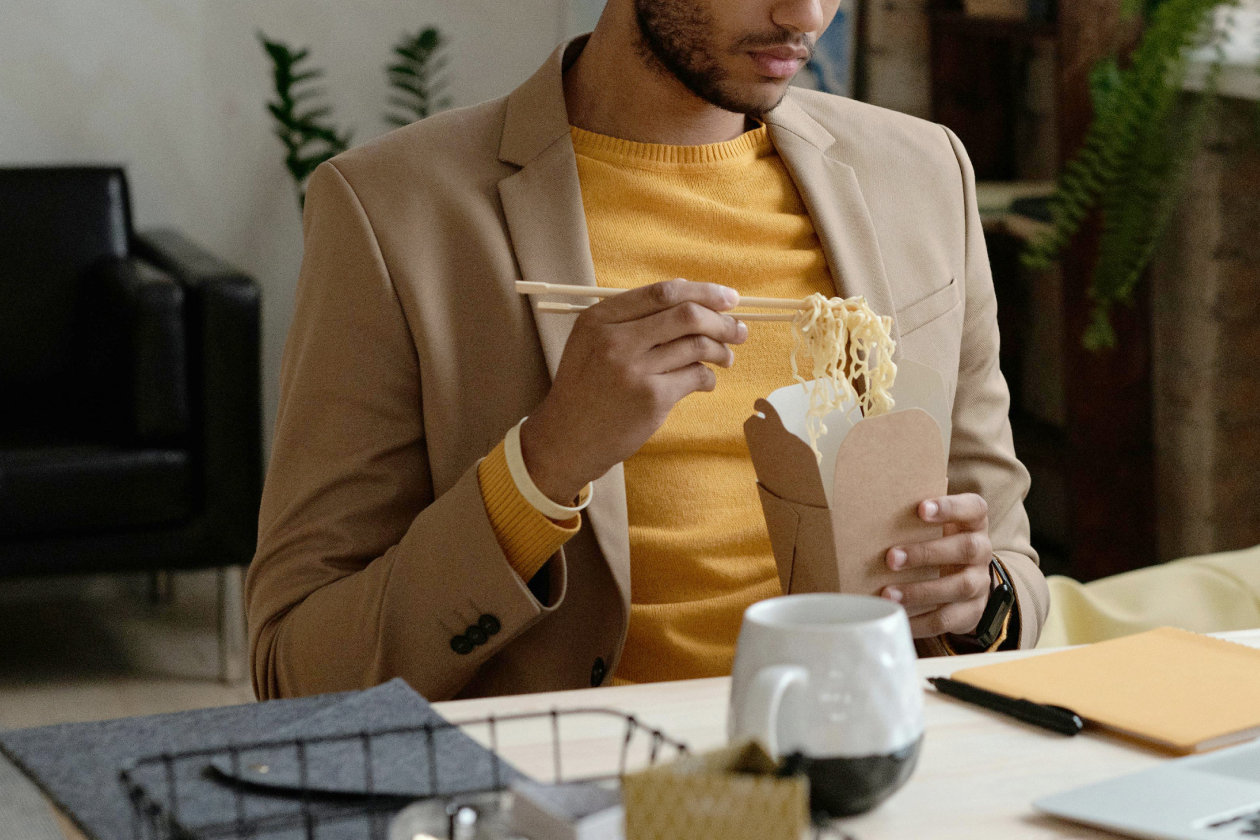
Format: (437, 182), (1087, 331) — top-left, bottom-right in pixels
(520, 280), (748, 505)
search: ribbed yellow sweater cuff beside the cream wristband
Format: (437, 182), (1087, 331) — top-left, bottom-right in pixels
(478, 441), (582, 583)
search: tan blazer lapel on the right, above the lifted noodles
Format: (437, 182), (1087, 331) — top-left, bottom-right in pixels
(766, 96), (901, 359)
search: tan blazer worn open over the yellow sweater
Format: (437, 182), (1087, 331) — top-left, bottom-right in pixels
(247, 40), (1048, 700)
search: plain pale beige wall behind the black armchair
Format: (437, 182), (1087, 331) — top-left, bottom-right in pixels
(0, 0), (570, 453)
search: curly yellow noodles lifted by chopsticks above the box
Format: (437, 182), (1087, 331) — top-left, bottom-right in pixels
(791, 293), (897, 463)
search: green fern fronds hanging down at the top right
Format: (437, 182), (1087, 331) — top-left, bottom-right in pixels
(1023, 0), (1239, 350)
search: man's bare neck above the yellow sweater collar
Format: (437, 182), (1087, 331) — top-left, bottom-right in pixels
(564, 4), (747, 146)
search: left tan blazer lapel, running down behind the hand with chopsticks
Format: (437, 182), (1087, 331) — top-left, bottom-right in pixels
(499, 39), (630, 611)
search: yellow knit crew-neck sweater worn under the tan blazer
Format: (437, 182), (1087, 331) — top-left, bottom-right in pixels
(479, 126), (835, 683)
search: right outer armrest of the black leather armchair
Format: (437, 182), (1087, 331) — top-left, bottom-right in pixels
(134, 229), (262, 563)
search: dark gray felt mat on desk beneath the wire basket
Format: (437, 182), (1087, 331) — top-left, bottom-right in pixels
(0, 680), (519, 840)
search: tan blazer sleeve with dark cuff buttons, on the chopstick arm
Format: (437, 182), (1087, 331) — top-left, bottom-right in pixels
(246, 162), (564, 700)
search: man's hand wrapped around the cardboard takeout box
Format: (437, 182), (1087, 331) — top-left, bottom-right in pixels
(881, 492), (993, 639)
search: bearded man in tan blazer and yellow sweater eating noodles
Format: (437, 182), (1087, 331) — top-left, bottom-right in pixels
(247, 0), (1046, 699)
